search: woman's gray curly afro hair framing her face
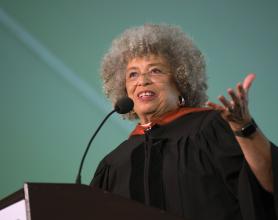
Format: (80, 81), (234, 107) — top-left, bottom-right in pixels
(101, 24), (207, 119)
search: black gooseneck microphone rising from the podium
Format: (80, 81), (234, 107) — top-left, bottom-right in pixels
(75, 96), (134, 184)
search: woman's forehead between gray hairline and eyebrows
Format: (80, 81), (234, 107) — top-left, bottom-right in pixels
(127, 54), (170, 69)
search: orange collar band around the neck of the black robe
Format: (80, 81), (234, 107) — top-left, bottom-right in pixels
(129, 107), (210, 136)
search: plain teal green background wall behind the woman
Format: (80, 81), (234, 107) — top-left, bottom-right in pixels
(0, 0), (278, 198)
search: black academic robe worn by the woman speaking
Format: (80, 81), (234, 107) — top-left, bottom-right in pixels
(91, 111), (278, 220)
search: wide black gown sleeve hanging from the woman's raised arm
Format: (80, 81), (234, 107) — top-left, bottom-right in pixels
(198, 115), (278, 220)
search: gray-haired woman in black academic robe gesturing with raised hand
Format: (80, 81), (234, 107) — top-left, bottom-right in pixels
(92, 24), (278, 220)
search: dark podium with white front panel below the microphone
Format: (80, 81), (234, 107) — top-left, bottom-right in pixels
(0, 183), (185, 220)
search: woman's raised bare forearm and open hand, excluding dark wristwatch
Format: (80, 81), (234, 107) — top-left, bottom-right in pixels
(207, 74), (273, 192)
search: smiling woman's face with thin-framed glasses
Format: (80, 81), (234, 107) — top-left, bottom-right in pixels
(126, 55), (180, 124)
